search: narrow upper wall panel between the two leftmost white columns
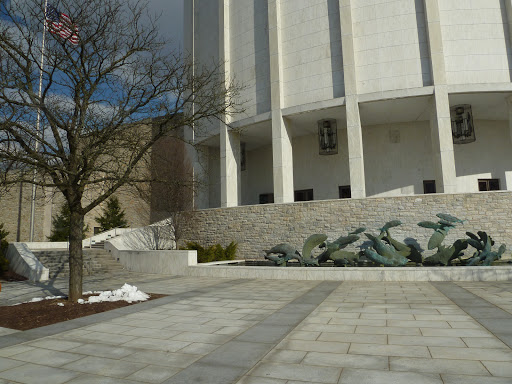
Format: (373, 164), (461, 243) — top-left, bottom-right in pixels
(230, 0), (270, 117)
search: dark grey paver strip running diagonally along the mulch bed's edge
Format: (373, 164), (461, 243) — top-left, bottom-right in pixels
(0, 279), (251, 349)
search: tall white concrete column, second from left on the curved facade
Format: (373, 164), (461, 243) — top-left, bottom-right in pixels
(268, 0), (294, 203)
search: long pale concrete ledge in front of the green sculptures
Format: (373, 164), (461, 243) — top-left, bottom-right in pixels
(187, 263), (512, 281)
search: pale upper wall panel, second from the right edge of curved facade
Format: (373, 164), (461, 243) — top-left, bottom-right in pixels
(352, 0), (432, 93)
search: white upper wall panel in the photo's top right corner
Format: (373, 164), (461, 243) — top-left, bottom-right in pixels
(439, 0), (511, 84)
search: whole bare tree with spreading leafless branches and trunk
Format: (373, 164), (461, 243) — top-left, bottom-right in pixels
(0, 0), (239, 301)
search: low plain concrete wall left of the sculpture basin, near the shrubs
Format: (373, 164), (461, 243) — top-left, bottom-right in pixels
(117, 250), (197, 275)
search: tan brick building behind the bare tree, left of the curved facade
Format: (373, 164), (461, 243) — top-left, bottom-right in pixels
(0, 122), (192, 242)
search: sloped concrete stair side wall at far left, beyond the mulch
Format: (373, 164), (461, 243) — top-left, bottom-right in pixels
(7, 243), (50, 282)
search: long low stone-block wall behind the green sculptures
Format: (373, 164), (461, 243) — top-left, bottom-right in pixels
(184, 191), (512, 258)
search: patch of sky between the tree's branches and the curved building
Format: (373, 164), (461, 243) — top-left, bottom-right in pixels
(148, 0), (184, 48)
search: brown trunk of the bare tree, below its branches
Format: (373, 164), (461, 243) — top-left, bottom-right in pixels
(69, 207), (84, 303)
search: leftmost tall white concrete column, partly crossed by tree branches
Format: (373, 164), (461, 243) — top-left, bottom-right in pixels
(219, 0), (241, 207)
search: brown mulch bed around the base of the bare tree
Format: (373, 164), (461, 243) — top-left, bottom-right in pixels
(0, 293), (166, 331)
